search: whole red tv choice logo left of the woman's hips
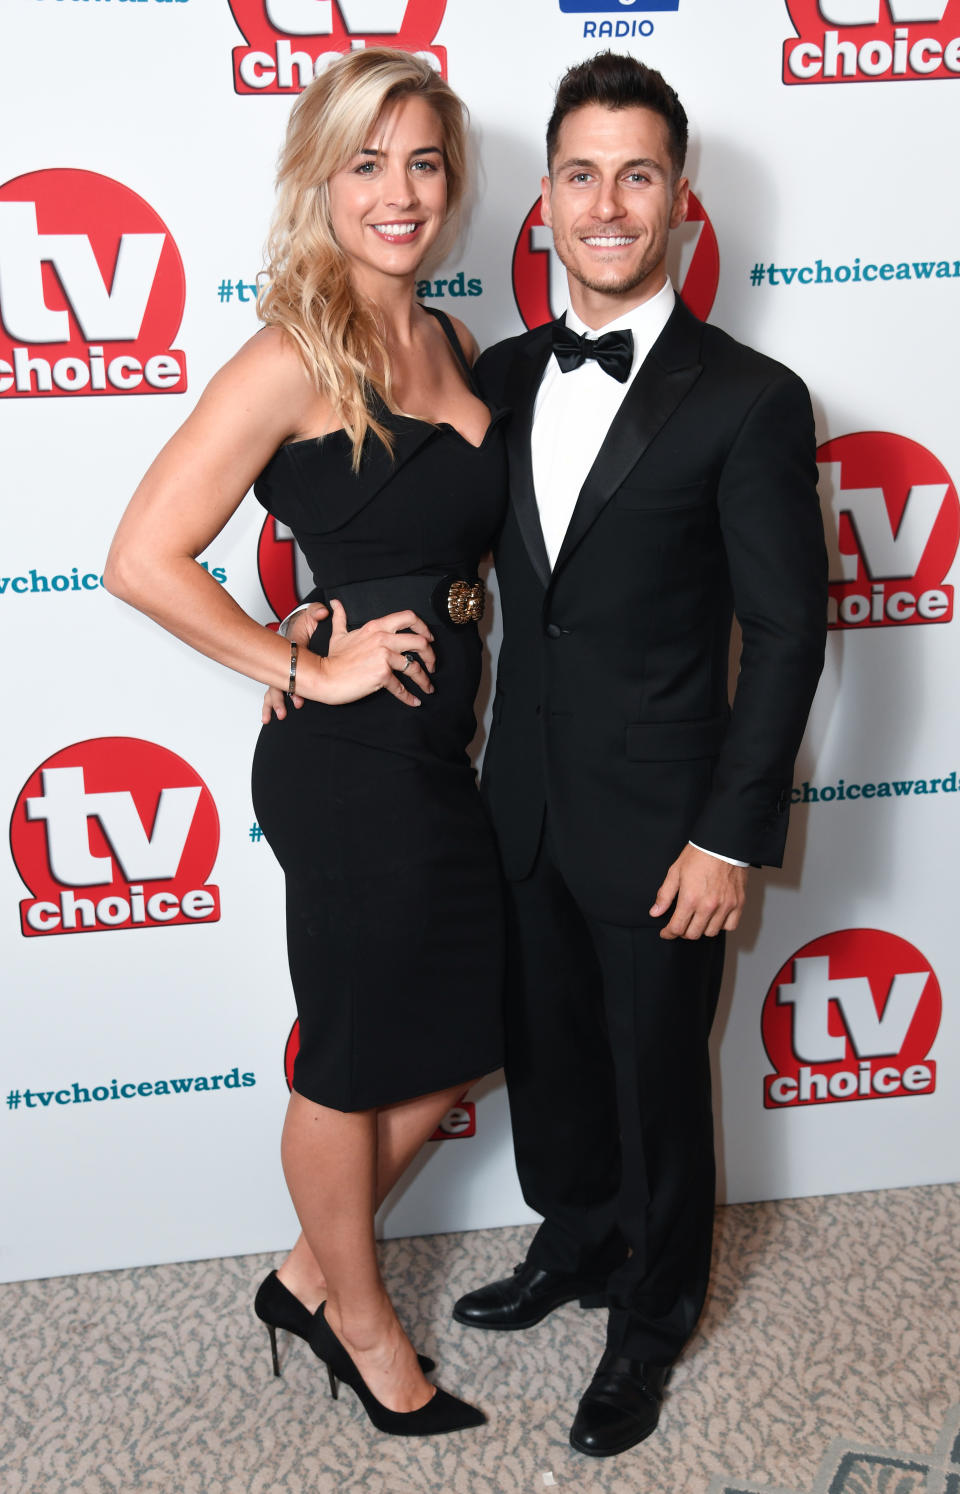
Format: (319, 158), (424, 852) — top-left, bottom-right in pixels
(10, 737), (219, 937)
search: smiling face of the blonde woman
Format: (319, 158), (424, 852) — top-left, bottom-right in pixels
(330, 96), (446, 293)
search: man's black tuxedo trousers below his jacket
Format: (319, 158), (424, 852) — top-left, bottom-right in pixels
(506, 831), (724, 1364)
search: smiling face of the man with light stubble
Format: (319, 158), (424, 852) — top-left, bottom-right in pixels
(540, 103), (688, 311)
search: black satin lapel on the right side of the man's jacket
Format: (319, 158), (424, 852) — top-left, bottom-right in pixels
(554, 300), (702, 575)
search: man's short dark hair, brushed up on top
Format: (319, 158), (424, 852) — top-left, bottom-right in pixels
(546, 52), (687, 176)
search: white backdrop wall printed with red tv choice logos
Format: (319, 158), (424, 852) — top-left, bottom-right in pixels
(0, 0), (960, 1279)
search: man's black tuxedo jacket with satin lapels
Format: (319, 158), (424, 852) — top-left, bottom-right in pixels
(475, 292), (827, 925)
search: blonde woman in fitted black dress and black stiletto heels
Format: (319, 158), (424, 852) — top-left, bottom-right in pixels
(105, 48), (505, 1434)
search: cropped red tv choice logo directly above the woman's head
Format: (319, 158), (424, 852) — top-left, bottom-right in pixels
(230, 0), (446, 94)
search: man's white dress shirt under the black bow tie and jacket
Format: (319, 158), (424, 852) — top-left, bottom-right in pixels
(530, 281), (748, 867)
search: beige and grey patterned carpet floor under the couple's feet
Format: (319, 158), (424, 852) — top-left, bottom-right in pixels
(0, 1185), (960, 1494)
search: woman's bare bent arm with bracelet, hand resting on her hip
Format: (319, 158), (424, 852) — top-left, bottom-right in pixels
(103, 327), (434, 705)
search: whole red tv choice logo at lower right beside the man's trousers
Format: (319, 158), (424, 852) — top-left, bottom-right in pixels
(761, 929), (942, 1110)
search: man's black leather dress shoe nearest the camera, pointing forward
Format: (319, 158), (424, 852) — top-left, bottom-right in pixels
(570, 1352), (670, 1458)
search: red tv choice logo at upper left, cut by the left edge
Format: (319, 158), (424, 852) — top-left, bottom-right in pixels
(0, 167), (187, 397)
